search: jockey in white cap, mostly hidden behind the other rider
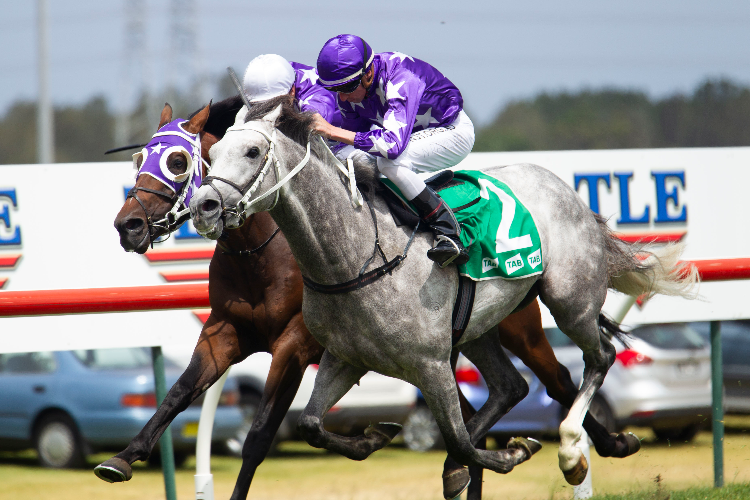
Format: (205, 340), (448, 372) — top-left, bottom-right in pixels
(243, 54), (341, 129)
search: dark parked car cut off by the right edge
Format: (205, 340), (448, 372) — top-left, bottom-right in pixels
(690, 321), (750, 413)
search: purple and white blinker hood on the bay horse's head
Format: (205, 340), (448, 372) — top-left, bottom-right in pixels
(133, 118), (203, 214)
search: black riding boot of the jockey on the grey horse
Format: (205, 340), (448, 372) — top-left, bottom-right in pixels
(411, 187), (469, 267)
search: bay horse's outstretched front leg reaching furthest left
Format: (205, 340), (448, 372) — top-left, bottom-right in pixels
(94, 313), (247, 483)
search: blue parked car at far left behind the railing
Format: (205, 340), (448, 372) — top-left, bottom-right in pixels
(0, 348), (242, 468)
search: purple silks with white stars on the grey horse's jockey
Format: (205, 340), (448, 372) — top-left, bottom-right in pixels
(337, 52), (463, 159)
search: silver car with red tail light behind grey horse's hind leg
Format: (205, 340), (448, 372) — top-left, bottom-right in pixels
(546, 323), (711, 441)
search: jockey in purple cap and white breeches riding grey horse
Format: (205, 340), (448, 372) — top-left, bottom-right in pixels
(314, 35), (474, 266)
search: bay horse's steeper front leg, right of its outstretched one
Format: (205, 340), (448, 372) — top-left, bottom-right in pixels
(232, 313), (323, 500)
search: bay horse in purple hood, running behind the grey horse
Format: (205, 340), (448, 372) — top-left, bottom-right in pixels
(103, 96), (640, 500)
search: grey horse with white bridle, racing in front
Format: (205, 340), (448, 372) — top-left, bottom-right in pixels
(190, 97), (697, 483)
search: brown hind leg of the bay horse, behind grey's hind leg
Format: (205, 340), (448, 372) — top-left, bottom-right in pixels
(498, 301), (640, 458)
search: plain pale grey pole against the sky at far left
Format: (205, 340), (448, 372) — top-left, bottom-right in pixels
(36, 0), (55, 163)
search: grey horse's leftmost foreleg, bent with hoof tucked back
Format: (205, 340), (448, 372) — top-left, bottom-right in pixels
(297, 351), (401, 460)
